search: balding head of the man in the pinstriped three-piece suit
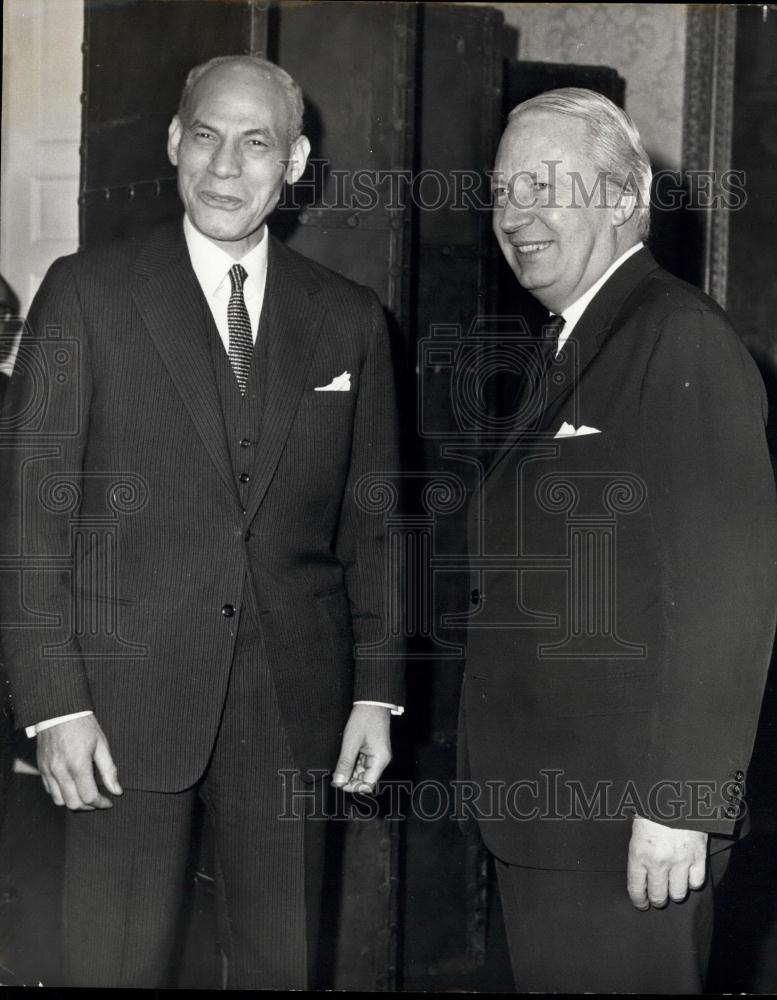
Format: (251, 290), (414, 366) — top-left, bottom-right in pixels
(167, 63), (310, 260)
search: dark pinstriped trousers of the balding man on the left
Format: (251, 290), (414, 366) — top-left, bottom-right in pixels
(63, 604), (326, 989)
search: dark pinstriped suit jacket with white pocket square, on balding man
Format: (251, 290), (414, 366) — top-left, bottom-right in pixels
(0, 224), (402, 791)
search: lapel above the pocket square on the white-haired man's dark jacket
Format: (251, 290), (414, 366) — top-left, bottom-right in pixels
(485, 248), (658, 486)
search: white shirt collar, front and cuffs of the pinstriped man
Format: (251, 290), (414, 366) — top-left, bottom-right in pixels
(25, 221), (404, 737)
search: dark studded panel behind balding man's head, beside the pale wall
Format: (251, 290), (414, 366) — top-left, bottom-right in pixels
(79, 0), (267, 247)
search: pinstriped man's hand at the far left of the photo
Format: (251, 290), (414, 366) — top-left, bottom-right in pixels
(36, 715), (122, 812)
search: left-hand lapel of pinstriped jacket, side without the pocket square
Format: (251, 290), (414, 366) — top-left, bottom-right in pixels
(132, 222), (237, 496)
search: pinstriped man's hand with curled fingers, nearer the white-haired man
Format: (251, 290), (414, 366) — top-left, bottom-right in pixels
(332, 705), (391, 792)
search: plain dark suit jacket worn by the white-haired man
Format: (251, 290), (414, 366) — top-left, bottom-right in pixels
(462, 250), (777, 869)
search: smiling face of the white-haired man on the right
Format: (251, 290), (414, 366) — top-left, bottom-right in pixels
(493, 110), (636, 313)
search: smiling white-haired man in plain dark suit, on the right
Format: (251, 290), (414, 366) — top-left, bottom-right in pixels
(462, 88), (777, 992)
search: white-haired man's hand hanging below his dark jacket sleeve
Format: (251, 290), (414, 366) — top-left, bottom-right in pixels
(626, 816), (707, 910)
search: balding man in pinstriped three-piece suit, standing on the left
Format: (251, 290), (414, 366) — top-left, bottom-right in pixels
(2, 57), (403, 988)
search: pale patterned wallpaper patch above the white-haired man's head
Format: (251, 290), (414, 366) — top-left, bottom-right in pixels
(492, 3), (686, 170)
